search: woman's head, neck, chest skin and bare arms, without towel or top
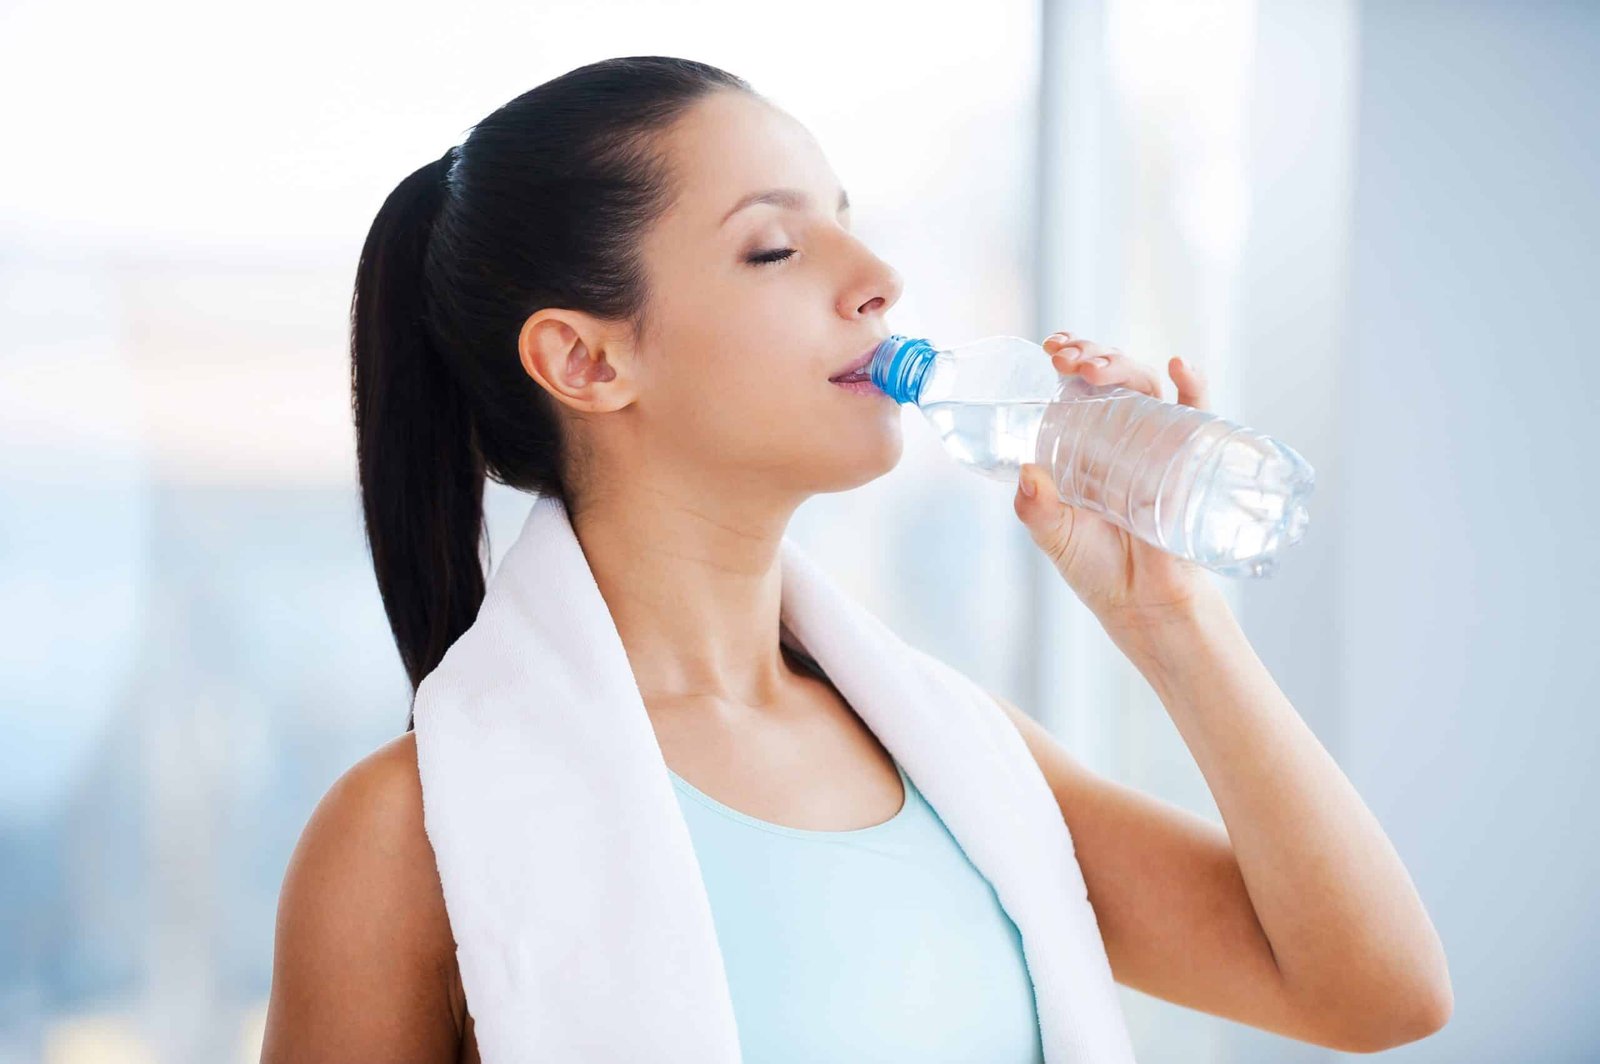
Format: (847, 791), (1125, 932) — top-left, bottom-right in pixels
(262, 58), (1451, 1062)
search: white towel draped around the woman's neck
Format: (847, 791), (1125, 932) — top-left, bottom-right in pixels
(414, 496), (1133, 1064)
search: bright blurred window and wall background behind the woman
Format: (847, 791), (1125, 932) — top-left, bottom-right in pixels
(0, 0), (1600, 1064)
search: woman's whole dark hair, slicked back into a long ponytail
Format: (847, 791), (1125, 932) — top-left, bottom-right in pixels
(350, 56), (754, 731)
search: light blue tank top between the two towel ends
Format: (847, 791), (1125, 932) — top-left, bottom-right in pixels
(667, 640), (1045, 1064)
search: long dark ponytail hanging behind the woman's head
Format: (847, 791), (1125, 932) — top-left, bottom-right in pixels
(350, 147), (485, 731)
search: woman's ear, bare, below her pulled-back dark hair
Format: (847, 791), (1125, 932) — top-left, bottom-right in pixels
(517, 307), (637, 413)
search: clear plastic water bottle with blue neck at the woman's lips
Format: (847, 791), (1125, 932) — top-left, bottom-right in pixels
(869, 334), (1315, 576)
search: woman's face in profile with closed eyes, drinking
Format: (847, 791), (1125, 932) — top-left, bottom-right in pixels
(544, 91), (902, 504)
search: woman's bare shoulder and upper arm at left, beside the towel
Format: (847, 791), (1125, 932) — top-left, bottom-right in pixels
(261, 733), (464, 1064)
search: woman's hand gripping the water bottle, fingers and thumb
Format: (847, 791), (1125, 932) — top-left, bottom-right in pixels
(1013, 333), (1216, 627)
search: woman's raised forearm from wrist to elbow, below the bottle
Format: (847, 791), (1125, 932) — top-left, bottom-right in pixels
(1107, 592), (1451, 1034)
